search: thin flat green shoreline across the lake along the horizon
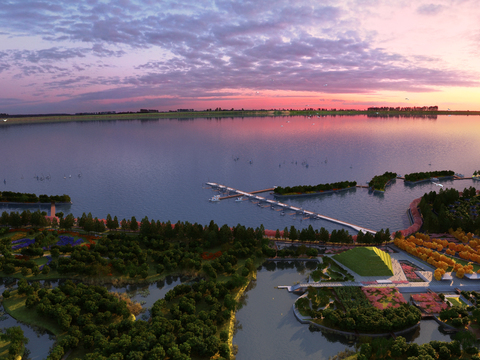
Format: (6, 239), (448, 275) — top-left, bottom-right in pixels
(0, 110), (480, 126)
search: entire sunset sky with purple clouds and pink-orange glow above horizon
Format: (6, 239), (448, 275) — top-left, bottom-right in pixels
(0, 0), (480, 114)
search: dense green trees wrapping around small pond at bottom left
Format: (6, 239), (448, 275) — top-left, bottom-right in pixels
(8, 274), (246, 360)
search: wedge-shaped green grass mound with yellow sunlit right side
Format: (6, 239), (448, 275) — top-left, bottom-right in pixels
(333, 247), (393, 276)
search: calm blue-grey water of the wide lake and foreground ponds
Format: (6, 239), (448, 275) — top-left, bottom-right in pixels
(0, 116), (480, 360)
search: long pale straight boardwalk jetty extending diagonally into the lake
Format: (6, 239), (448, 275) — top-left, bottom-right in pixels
(206, 182), (376, 234)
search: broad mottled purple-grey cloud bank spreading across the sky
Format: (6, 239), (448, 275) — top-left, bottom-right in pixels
(0, 0), (479, 112)
